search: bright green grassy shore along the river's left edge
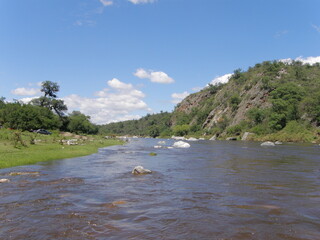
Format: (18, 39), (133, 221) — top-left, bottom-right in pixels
(0, 130), (123, 169)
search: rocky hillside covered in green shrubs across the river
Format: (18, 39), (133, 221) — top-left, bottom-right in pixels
(99, 61), (320, 142)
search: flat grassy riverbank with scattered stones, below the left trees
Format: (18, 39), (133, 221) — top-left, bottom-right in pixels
(0, 129), (122, 168)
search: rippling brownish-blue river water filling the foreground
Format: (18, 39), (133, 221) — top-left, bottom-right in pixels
(0, 139), (320, 240)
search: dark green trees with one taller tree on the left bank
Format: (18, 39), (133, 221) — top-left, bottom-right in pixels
(0, 81), (98, 134)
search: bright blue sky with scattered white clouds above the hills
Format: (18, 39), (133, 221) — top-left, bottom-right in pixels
(0, 0), (320, 124)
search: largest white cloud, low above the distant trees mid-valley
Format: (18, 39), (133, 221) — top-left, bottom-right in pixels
(63, 78), (150, 124)
